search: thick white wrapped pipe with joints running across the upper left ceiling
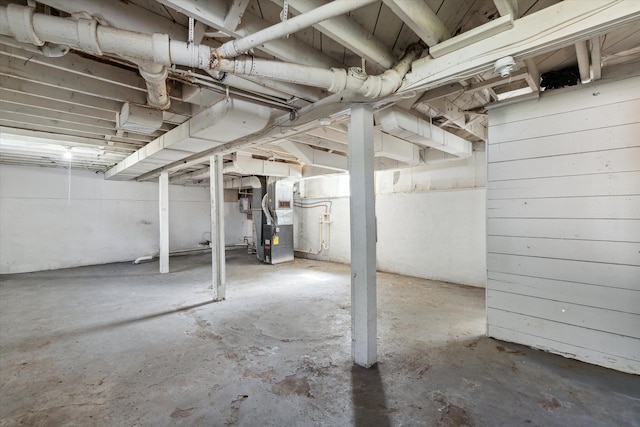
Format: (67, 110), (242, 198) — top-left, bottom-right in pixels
(0, 0), (422, 98)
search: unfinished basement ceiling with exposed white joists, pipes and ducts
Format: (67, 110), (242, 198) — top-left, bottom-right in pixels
(0, 0), (640, 184)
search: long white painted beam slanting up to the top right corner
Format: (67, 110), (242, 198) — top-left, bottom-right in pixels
(401, 0), (640, 90)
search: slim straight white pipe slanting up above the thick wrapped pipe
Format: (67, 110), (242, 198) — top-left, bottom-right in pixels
(215, 0), (377, 59)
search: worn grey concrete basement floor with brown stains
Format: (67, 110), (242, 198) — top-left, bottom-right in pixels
(0, 251), (640, 426)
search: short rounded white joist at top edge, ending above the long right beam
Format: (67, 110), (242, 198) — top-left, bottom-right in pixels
(383, 0), (451, 46)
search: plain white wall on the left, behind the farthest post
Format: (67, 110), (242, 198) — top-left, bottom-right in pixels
(0, 165), (210, 273)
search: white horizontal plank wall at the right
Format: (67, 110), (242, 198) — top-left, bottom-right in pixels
(487, 77), (640, 374)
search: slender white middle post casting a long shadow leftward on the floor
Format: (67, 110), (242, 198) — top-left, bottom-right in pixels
(209, 154), (226, 301)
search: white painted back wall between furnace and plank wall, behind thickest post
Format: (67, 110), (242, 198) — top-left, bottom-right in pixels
(294, 152), (486, 287)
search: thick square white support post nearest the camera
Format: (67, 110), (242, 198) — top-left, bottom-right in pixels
(349, 105), (377, 368)
